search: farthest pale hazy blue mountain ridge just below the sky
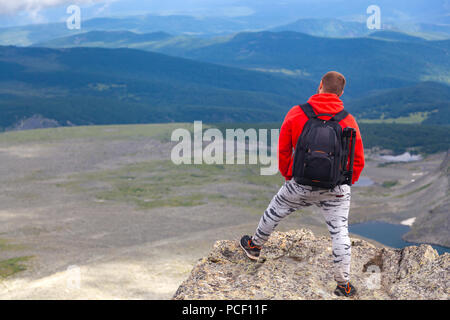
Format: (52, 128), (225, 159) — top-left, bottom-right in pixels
(0, 14), (450, 46)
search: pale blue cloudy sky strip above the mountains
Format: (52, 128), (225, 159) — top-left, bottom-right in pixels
(0, 0), (450, 26)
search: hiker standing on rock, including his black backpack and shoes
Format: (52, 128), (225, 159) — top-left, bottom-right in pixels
(240, 71), (364, 297)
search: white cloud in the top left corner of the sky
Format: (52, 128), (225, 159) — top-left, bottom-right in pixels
(0, 0), (110, 16)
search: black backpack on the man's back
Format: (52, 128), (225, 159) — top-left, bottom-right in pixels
(292, 103), (351, 189)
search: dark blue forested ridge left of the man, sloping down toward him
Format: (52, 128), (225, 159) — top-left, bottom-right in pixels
(0, 47), (315, 128)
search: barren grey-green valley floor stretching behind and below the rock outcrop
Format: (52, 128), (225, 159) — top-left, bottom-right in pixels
(0, 124), (449, 299)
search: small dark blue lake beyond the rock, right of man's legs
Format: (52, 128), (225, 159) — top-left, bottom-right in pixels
(349, 221), (450, 254)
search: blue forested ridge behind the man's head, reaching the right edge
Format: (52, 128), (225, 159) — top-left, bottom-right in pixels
(167, 32), (450, 98)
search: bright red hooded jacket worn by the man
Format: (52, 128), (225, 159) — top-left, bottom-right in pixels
(278, 93), (364, 183)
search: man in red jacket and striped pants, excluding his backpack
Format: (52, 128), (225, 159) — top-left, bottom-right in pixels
(240, 71), (364, 297)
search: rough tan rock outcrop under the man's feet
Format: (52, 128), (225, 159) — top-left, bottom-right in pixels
(173, 229), (450, 300)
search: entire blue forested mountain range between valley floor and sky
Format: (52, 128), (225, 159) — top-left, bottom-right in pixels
(0, 15), (450, 132)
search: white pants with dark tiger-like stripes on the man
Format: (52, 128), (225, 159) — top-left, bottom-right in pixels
(253, 180), (351, 283)
